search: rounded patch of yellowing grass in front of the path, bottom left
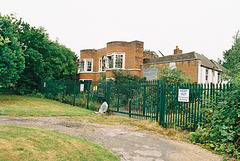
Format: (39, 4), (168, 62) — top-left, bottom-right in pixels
(0, 125), (119, 161)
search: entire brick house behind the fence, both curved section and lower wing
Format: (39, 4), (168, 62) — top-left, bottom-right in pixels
(78, 41), (226, 83)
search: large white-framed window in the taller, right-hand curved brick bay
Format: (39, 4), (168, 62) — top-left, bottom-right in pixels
(106, 53), (125, 69)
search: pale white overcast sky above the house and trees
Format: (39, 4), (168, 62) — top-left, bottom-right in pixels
(0, 0), (240, 60)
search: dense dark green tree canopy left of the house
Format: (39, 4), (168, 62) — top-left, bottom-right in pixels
(0, 16), (77, 94)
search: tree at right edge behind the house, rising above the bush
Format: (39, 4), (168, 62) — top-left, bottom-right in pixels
(221, 31), (240, 78)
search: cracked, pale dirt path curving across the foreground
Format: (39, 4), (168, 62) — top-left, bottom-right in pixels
(0, 116), (221, 161)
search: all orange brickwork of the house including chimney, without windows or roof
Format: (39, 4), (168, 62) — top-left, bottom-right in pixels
(79, 41), (200, 82)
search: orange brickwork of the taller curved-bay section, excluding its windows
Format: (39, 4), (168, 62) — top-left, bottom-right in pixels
(78, 41), (146, 82)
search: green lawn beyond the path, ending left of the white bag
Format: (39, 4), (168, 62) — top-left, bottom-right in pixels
(0, 95), (93, 116)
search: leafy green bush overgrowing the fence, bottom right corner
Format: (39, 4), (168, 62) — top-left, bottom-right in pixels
(191, 66), (240, 159)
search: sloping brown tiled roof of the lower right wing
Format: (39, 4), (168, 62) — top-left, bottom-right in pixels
(143, 51), (227, 71)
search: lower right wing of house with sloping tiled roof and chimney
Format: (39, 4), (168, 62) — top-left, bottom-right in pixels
(142, 46), (226, 83)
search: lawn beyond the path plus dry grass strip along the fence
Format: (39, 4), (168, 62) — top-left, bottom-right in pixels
(0, 95), (186, 140)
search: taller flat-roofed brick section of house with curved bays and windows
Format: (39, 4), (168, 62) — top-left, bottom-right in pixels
(78, 41), (157, 82)
